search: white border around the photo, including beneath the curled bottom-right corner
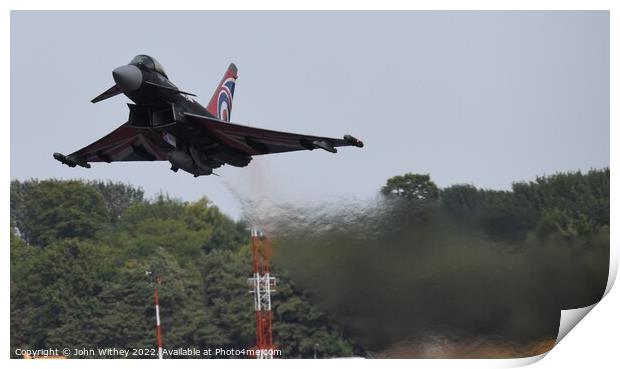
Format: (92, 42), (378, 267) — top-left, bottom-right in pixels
(0, 0), (620, 368)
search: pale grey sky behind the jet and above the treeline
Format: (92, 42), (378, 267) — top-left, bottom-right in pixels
(11, 11), (609, 217)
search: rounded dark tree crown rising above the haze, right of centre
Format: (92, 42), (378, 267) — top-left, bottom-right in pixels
(381, 173), (439, 201)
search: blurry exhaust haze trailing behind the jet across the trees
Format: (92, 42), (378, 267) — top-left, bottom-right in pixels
(233, 191), (609, 357)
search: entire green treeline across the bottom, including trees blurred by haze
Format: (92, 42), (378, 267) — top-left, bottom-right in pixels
(10, 169), (610, 358)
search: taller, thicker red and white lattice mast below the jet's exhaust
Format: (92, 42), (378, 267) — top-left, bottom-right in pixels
(248, 229), (276, 359)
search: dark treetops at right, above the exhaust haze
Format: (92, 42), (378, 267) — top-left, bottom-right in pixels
(382, 168), (610, 239)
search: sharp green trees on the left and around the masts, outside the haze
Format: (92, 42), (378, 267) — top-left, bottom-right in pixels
(10, 180), (354, 357)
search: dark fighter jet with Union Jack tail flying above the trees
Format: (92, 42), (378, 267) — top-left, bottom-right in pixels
(54, 55), (364, 177)
